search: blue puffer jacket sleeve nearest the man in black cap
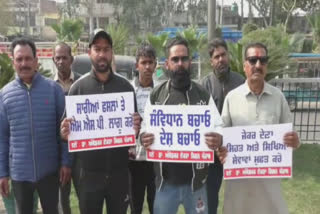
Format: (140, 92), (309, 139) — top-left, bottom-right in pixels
(56, 83), (72, 167)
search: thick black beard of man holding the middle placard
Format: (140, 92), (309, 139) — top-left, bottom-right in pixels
(168, 68), (191, 89)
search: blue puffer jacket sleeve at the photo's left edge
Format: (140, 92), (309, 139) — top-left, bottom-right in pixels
(0, 92), (10, 178)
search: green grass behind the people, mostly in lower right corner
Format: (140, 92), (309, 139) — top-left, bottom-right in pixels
(71, 144), (320, 214)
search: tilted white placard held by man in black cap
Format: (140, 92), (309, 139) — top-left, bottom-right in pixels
(66, 92), (135, 152)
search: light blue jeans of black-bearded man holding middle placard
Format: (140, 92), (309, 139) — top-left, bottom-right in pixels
(154, 182), (208, 214)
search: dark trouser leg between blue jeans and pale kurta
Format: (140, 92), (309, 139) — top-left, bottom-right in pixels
(207, 163), (223, 214)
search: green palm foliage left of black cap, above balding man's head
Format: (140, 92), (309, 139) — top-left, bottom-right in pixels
(51, 19), (83, 42)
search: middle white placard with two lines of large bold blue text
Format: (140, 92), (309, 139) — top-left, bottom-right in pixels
(144, 101), (221, 163)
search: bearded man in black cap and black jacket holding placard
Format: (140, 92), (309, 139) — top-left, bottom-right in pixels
(61, 29), (140, 214)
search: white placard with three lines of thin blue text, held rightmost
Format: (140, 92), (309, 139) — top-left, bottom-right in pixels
(223, 123), (292, 180)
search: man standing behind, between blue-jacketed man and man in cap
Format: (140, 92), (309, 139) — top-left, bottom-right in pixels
(52, 42), (80, 214)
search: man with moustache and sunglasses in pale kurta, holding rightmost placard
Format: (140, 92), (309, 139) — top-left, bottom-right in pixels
(222, 43), (299, 214)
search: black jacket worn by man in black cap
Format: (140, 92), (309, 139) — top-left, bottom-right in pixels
(69, 71), (137, 175)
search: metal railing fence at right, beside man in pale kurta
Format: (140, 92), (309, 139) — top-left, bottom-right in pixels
(270, 78), (320, 143)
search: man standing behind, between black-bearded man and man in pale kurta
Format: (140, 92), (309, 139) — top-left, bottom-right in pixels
(201, 39), (244, 214)
